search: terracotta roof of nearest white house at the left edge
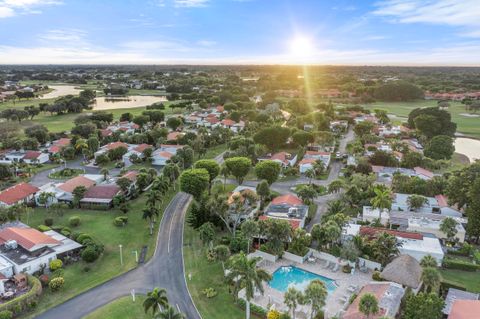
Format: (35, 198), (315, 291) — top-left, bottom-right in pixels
(0, 227), (60, 250)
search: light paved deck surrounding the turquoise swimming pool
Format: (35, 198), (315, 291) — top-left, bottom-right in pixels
(244, 259), (372, 319)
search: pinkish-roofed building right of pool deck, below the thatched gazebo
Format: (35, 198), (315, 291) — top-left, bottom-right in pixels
(342, 282), (405, 319)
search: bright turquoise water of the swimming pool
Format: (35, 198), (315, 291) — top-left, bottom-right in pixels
(268, 266), (337, 293)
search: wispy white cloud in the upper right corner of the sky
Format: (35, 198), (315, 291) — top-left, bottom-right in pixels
(372, 0), (480, 36)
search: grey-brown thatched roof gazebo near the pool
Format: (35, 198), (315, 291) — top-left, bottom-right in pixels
(381, 255), (422, 289)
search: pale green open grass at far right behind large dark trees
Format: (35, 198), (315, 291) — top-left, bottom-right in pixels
(365, 100), (480, 138)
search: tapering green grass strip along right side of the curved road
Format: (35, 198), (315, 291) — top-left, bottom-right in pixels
(183, 225), (245, 319)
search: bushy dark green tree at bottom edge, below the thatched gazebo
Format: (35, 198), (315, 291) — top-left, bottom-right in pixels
(402, 292), (445, 319)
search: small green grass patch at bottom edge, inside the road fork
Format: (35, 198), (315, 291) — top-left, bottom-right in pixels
(84, 295), (152, 319)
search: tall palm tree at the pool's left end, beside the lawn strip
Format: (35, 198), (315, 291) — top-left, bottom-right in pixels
(227, 252), (272, 319)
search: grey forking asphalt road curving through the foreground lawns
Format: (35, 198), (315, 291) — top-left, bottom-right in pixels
(36, 192), (201, 319)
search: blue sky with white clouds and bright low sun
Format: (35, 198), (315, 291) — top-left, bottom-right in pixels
(0, 0), (480, 66)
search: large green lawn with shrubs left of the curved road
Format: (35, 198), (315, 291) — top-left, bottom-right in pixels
(23, 186), (176, 318)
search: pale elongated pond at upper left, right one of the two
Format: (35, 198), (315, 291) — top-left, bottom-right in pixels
(93, 95), (167, 111)
